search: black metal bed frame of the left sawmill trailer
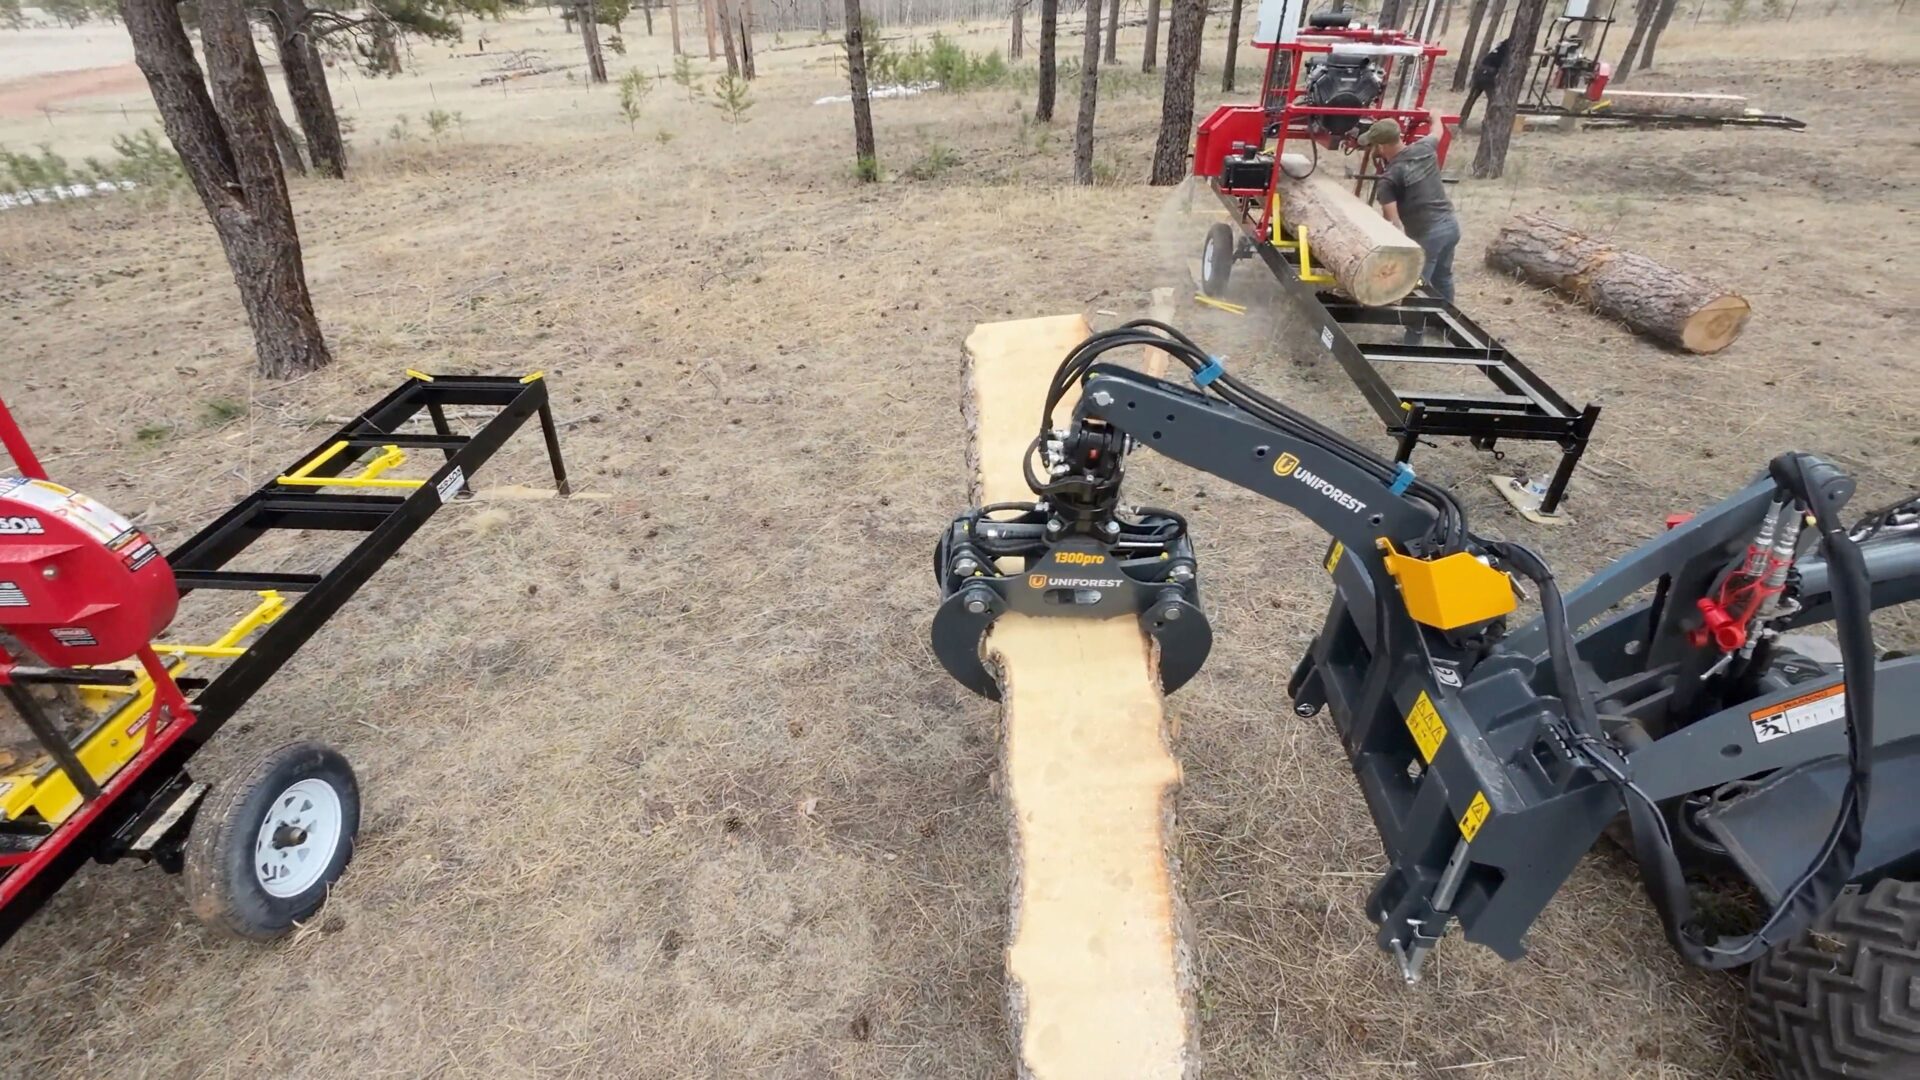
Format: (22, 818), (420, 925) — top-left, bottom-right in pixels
(0, 373), (568, 944)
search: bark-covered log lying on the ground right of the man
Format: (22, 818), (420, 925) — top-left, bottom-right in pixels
(1486, 213), (1753, 354)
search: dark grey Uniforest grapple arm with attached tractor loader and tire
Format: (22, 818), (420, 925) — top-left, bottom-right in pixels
(933, 319), (1920, 1078)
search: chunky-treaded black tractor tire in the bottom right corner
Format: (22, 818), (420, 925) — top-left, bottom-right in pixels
(1747, 880), (1920, 1080)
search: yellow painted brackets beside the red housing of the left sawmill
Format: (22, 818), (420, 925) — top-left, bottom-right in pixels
(0, 592), (286, 824)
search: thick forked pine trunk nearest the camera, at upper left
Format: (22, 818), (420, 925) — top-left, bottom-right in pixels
(121, 0), (332, 379)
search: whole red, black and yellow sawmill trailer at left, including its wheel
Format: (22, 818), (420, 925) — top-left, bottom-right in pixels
(0, 373), (566, 942)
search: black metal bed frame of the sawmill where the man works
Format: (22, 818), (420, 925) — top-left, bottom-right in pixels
(1215, 192), (1599, 515)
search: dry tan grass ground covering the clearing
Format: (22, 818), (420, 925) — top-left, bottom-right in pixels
(0, 4), (1920, 1080)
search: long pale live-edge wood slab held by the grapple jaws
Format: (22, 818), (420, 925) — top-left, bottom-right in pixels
(966, 315), (1194, 1080)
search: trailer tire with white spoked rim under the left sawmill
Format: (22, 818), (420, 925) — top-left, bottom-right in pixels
(184, 742), (359, 942)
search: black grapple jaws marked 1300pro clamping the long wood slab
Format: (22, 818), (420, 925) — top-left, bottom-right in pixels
(933, 502), (1213, 700)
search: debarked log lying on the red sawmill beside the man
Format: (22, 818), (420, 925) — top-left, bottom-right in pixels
(1279, 154), (1425, 306)
